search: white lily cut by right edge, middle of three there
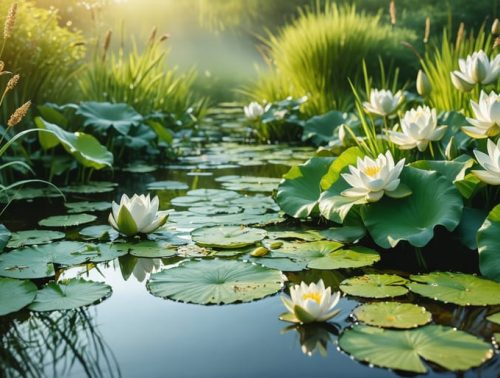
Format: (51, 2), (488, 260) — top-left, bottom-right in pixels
(462, 91), (500, 139)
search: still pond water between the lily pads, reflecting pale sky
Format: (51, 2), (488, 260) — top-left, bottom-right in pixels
(0, 107), (500, 377)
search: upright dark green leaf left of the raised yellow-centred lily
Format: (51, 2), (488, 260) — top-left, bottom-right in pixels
(276, 157), (333, 218)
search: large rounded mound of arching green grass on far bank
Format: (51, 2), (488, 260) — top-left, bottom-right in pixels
(246, 2), (418, 115)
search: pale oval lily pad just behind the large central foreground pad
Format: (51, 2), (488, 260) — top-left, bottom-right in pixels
(191, 226), (267, 248)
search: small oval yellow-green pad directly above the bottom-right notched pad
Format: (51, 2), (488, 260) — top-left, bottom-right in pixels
(353, 302), (432, 328)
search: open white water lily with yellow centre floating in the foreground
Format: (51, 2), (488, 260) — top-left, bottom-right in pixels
(281, 280), (340, 323)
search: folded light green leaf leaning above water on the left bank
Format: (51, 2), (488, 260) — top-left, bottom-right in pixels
(35, 117), (113, 169)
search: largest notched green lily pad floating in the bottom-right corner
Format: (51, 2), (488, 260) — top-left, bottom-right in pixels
(338, 325), (493, 373)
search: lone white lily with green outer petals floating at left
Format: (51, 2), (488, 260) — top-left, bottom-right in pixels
(108, 194), (168, 236)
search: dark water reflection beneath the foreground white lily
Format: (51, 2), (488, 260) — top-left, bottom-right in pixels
(281, 323), (340, 357)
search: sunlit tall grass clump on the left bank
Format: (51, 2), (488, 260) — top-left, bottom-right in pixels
(80, 33), (196, 114)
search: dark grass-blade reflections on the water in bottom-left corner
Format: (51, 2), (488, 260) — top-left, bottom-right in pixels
(0, 308), (121, 377)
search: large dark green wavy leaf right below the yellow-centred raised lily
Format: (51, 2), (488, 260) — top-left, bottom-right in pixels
(364, 167), (463, 248)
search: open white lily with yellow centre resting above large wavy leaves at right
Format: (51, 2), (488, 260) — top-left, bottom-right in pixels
(341, 151), (411, 203)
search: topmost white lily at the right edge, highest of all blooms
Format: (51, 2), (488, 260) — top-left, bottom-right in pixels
(450, 50), (500, 92)
